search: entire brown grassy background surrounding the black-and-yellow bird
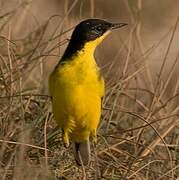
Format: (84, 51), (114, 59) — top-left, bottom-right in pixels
(0, 0), (179, 179)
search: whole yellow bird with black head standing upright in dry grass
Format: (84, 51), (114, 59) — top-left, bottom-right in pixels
(49, 19), (127, 166)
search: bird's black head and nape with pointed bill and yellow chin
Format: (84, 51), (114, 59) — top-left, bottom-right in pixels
(62, 19), (127, 59)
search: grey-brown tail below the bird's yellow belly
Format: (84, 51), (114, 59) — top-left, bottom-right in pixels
(74, 139), (91, 166)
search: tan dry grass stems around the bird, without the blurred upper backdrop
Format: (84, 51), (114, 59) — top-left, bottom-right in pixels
(0, 0), (179, 180)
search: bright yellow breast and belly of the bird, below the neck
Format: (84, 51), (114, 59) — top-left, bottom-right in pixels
(49, 55), (104, 142)
